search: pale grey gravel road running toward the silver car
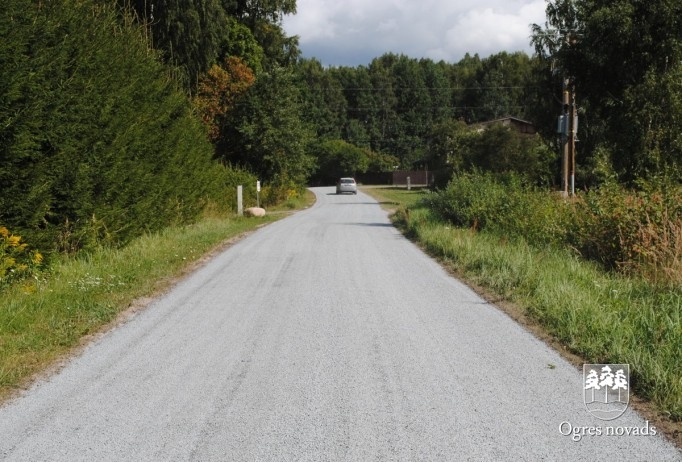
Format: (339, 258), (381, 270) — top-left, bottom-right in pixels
(0, 188), (682, 462)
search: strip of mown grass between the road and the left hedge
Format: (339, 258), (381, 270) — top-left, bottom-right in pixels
(0, 193), (314, 400)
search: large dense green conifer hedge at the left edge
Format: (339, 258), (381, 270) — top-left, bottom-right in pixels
(0, 0), (244, 251)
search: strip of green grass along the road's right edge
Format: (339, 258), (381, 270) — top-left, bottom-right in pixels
(358, 189), (682, 445)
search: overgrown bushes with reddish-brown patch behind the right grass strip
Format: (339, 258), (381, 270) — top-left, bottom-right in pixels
(429, 173), (682, 284)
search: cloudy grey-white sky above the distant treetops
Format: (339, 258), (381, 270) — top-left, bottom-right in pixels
(284, 0), (546, 67)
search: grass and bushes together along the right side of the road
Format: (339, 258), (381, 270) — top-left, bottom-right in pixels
(366, 184), (682, 422)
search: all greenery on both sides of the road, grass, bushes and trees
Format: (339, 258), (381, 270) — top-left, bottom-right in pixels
(0, 0), (682, 440)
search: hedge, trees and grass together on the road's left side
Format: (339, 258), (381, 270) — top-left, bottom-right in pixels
(0, 0), (312, 395)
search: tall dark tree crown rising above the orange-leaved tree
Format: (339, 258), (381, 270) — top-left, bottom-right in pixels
(115, 0), (299, 84)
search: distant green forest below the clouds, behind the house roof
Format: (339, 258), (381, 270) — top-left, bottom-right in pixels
(297, 53), (533, 170)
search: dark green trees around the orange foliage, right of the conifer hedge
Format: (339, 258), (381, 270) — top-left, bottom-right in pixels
(115, 0), (304, 196)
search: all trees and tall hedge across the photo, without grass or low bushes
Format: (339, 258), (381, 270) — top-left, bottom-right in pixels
(0, 0), (682, 274)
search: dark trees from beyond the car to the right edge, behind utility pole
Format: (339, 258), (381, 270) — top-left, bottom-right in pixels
(297, 0), (682, 188)
